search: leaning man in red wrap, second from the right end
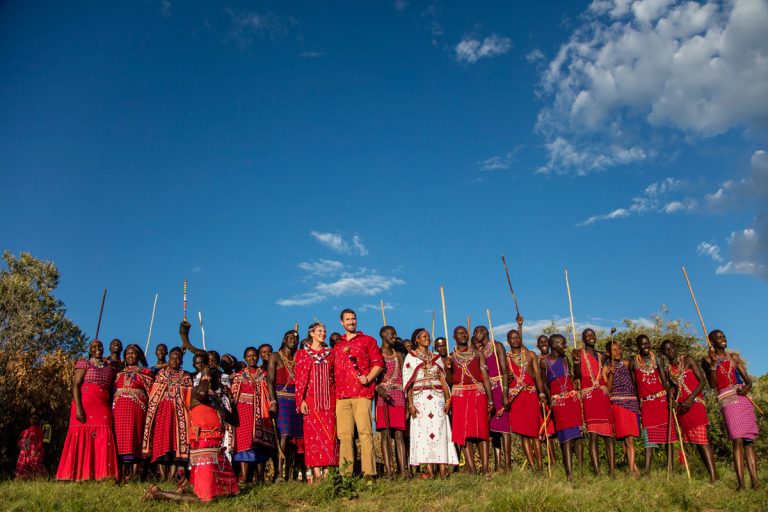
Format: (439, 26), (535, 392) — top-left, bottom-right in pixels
(659, 340), (717, 483)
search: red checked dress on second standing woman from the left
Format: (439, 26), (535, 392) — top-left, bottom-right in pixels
(112, 366), (154, 459)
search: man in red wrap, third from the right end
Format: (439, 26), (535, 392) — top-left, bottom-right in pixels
(630, 334), (677, 473)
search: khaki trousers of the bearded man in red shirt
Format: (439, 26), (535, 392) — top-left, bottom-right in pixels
(336, 398), (376, 476)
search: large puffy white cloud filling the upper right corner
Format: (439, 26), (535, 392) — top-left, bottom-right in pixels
(537, 0), (768, 174)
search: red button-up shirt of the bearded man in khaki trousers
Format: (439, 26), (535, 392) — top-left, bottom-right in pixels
(332, 331), (384, 400)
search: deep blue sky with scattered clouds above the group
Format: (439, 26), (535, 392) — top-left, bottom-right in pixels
(0, 0), (768, 373)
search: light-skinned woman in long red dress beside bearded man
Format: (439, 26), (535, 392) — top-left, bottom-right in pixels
(296, 322), (339, 479)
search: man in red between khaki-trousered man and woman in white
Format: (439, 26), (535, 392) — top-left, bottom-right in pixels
(376, 325), (410, 477)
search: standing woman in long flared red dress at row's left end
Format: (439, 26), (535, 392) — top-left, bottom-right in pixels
(56, 340), (117, 480)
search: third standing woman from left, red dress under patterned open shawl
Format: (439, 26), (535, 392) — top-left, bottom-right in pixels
(141, 346), (192, 480)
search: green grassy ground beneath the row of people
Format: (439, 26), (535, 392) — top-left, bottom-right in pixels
(0, 467), (768, 512)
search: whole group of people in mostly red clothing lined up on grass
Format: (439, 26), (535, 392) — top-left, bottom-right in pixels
(43, 309), (759, 501)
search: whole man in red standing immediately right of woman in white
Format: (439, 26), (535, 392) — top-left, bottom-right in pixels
(447, 325), (496, 476)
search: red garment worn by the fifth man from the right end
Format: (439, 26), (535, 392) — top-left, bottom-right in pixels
(580, 349), (613, 437)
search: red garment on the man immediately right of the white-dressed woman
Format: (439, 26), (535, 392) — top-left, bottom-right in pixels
(451, 349), (490, 445)
